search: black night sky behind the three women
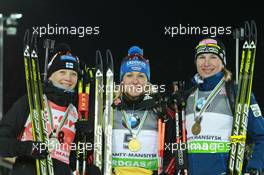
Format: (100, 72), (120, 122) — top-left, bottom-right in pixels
(0, 0), (264, 112)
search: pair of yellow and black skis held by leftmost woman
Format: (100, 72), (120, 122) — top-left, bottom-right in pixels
(23, 30), (54, 175)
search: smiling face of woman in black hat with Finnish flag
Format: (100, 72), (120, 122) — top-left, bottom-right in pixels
(49, 69), (78, 90)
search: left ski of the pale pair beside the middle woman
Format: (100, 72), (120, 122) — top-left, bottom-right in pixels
(94, 50), (104, 170)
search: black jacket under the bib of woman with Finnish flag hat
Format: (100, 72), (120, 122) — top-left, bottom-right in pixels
(0, 83), (95, 175)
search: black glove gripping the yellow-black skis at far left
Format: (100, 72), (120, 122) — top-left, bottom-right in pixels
(27, 141), (49, 159)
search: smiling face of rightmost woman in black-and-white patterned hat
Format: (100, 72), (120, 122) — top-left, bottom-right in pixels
(196, 53), (224, 79)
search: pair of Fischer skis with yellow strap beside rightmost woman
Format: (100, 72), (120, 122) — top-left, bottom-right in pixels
(228, 21), (257, 175)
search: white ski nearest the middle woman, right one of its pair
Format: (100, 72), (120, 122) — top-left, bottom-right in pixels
(104, 50), (114, 175)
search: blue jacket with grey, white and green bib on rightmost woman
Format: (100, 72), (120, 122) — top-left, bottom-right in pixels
(186, 72), (264, 175)
